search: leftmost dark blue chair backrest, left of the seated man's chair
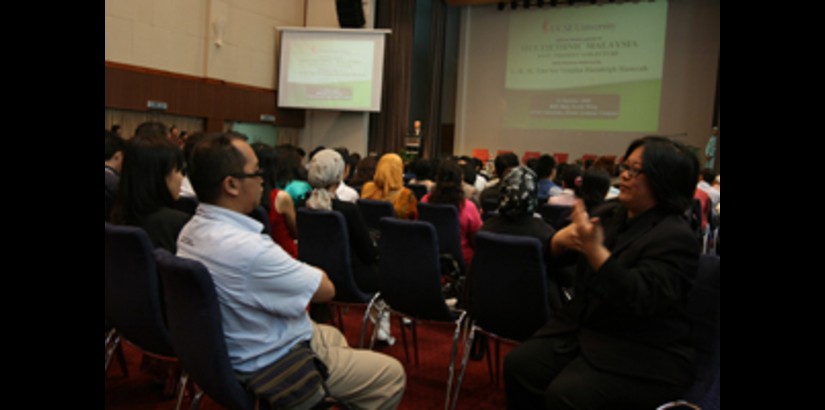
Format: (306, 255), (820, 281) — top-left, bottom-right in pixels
(104, 223), (175, 357)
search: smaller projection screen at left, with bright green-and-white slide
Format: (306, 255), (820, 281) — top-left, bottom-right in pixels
(278, 29), (385, 111)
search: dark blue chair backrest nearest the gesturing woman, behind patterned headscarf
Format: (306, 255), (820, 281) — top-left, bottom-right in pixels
(469, 231), (550, 341)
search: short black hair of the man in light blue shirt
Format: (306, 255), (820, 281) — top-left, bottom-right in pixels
(189, 133), (246, 204)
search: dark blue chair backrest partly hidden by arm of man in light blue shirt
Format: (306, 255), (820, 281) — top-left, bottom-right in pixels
(298, 208), (370, 303)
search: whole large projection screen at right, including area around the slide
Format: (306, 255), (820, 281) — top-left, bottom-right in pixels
(454, 0), (720, 160)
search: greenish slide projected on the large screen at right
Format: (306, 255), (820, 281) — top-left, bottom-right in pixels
(504, 1), (667, 131)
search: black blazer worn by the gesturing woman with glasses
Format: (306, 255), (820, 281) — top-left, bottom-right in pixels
(536, 206), (699, 385)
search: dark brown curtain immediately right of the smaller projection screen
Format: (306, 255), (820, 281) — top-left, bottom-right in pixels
(368, 0), (415, 154)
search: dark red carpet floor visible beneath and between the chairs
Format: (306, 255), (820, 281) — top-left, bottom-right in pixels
(105, 308), (511, 410)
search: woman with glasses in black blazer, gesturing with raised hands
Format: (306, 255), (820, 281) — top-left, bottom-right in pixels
(504, 137), (699, 409)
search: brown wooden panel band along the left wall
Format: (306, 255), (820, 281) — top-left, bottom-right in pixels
(105, 61), (305, 131)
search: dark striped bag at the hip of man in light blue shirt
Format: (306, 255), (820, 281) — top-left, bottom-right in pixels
(237, 341), (329, 410)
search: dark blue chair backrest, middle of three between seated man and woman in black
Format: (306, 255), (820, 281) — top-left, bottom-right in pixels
(378, 218), (453, 321)
